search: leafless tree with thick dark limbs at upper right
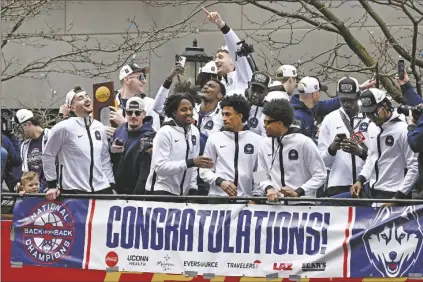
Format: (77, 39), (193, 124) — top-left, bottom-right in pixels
(232, 0), (423, 101)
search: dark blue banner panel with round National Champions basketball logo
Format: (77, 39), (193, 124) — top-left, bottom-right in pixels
(11, 198), (89, 268)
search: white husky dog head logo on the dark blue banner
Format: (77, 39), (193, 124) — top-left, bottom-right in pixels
(363, 206), (423, 278)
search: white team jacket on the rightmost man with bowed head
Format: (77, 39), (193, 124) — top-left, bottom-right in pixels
(359, 112), (418, 198)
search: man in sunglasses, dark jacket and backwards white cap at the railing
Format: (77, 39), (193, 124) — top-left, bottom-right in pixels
(110, 97), (155, 194)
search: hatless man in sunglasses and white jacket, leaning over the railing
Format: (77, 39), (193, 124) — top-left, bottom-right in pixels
(258, 99), (326, 203)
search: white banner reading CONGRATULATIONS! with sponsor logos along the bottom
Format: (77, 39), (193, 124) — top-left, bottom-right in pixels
(84, 200), (353, 277)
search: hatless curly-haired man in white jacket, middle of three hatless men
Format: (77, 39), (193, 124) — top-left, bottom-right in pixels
(200, 94), (263, 203)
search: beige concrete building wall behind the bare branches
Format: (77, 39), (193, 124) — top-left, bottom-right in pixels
(2, 0), (423, 108)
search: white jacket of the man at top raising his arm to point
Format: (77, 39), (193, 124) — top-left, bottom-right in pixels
(220, 24), (253, 93)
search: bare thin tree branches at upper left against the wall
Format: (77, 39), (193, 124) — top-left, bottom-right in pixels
(1, 0), (217, 82)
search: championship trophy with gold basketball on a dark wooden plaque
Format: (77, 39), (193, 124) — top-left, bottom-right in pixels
(93, 81), (117, 127)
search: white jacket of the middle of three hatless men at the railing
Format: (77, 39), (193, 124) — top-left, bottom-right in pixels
(200, 130), (263, 196)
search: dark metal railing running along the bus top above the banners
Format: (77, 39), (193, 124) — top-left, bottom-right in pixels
(1, 192), (423, 205)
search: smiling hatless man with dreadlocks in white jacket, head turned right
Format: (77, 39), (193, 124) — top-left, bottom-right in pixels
(146, 94), (213, 201)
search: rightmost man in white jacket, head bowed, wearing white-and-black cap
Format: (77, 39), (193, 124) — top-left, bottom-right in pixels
(350, 88), (418, 199)
